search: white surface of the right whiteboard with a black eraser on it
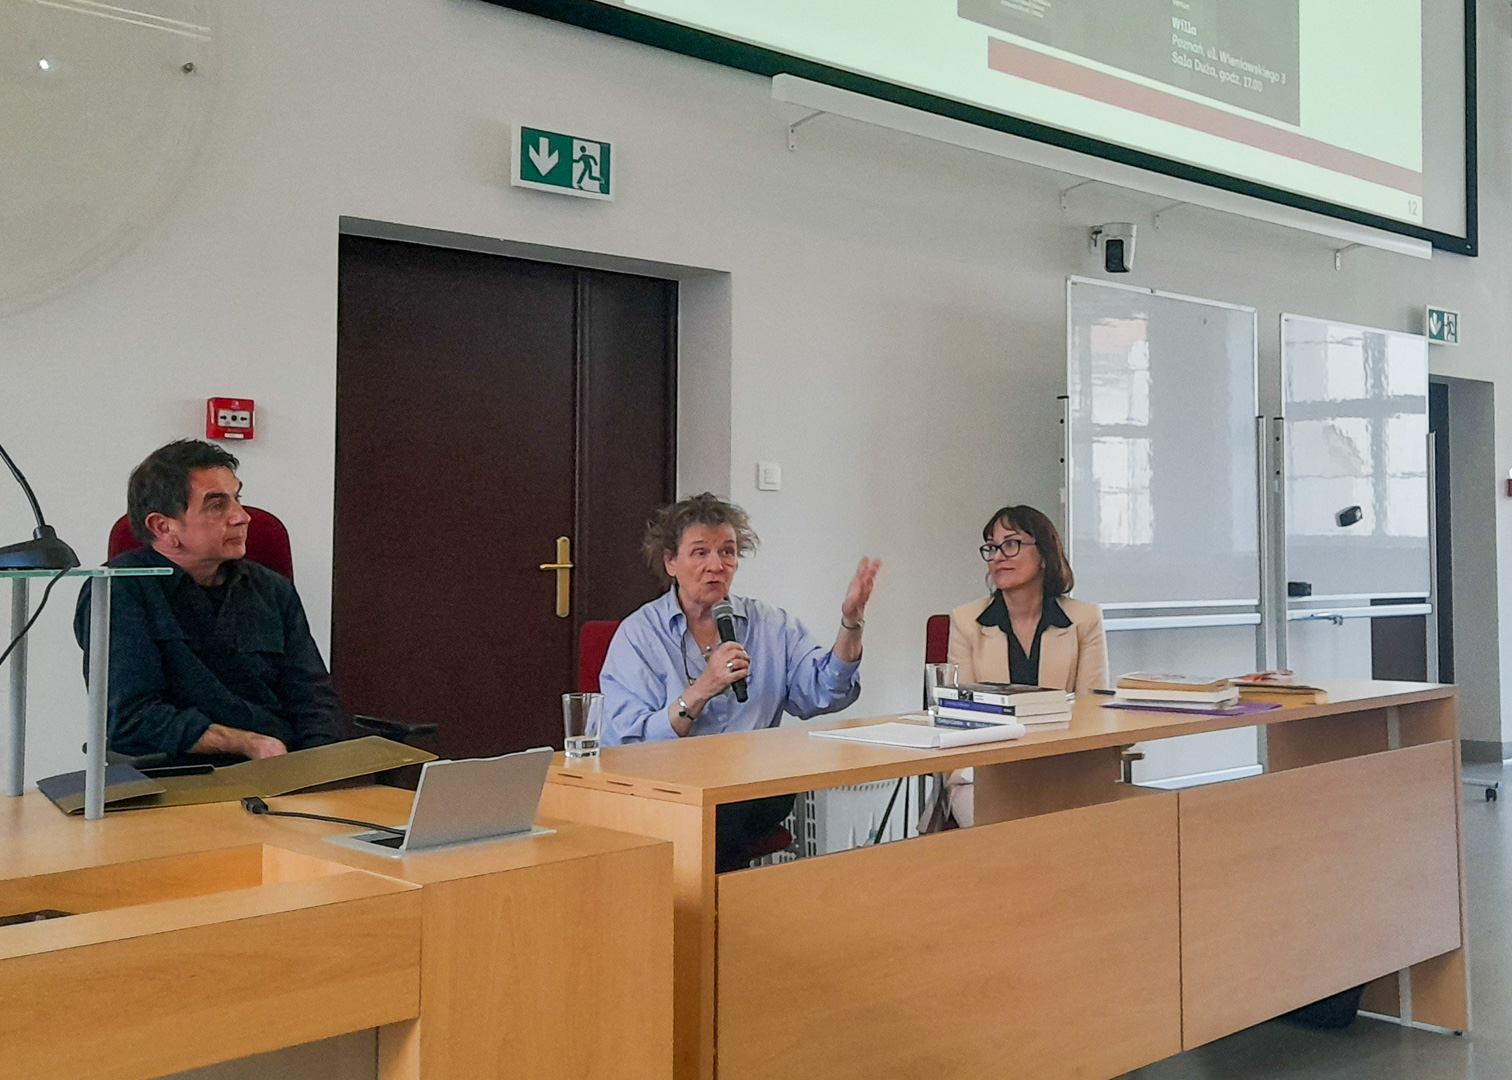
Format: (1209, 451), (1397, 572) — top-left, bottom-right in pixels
(1281, 315), (1429, 595)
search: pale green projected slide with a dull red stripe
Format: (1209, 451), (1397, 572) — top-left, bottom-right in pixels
(618, 0), (1423, 224)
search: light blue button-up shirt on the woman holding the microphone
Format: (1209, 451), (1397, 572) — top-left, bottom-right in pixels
(599, 588), (860, 746)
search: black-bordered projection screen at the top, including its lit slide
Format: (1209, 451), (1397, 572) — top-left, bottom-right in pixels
(490, 0), (1476, 254)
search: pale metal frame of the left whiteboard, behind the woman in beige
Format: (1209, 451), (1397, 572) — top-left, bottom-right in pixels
(1060, 274), (1272, 669)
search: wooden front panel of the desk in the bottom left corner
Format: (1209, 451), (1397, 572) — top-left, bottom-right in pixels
(0, 877), (420, 1080)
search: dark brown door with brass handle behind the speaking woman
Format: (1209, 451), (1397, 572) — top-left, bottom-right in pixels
(340, 236), (676, 756)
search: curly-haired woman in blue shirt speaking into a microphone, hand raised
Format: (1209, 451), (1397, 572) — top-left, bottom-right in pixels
(599, 493), (881, 870)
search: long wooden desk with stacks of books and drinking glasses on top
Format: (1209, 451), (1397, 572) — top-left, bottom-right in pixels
(543, 682), (1468, 1080)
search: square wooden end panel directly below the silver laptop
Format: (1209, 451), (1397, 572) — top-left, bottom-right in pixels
(405, 844), (671, 1080)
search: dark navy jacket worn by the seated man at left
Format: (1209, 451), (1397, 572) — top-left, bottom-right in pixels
(74, 549), (342, 756)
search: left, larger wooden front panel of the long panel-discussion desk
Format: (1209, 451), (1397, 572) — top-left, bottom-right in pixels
(717, 793), (1181, 1080)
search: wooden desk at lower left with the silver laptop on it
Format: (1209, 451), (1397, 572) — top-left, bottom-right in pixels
(0, 787), (671, 1080)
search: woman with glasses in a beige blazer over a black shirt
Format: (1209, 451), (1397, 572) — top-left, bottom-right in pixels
(942, 507), (1108, 826)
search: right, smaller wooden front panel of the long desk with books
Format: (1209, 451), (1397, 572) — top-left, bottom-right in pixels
(1179, 741), (1461, 1048)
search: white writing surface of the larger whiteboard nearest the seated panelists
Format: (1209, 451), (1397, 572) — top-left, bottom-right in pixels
(1066, 277), (1261, 605)
